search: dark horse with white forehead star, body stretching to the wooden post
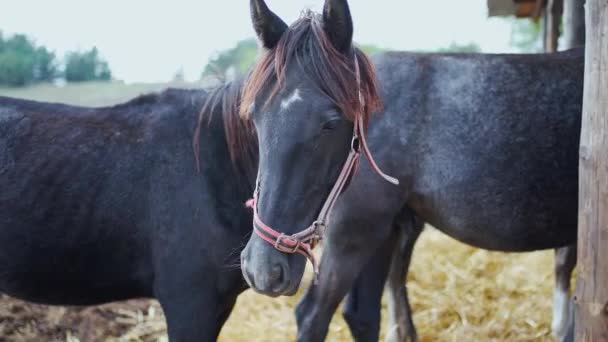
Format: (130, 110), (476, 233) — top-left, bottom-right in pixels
(241, 0), (584, 341)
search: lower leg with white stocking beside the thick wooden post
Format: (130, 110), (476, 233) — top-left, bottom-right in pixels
(551, 244), (576, 341)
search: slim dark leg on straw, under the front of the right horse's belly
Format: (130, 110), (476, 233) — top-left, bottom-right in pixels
(386, 211), (424, 342)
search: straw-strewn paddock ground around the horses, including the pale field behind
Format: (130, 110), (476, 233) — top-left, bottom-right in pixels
(0, 83), (553, 342)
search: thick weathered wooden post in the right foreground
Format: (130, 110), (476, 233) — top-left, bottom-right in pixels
(574, 0), (608, 342)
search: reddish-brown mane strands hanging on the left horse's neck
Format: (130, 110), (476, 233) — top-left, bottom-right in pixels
(192, 80), (258, 175)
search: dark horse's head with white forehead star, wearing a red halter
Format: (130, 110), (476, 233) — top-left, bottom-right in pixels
(241, 0), (379, 296)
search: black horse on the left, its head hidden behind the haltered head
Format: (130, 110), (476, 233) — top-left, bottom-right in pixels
(0, 86), (257, 341)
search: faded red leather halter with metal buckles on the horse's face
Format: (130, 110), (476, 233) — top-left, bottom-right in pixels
(247, 55), (399, 284)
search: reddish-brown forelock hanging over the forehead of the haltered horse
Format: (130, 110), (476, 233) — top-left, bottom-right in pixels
(240, 11), (381, 128)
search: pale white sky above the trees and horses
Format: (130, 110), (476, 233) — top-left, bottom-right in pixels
(0, 0), (512, 82)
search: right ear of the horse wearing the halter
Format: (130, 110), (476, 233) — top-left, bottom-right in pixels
(323, 0), (353, 52)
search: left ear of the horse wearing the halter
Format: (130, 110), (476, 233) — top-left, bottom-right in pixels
(250, 0), (287, 50)
